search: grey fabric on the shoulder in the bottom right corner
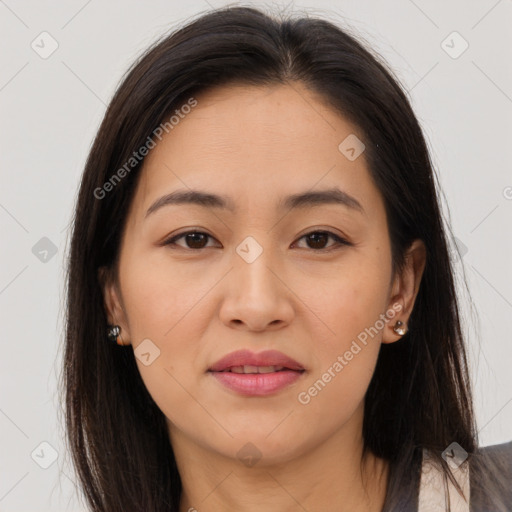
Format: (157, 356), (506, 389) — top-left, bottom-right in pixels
(469, 441), (512, 512)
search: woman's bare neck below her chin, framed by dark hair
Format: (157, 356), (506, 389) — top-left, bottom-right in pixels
(171, 406), (389, 512)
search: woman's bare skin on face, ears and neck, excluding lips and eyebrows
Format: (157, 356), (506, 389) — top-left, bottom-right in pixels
(100, 83), (425, 512)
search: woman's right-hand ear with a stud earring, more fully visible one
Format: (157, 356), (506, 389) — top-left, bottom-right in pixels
(382, 239), (427, 343)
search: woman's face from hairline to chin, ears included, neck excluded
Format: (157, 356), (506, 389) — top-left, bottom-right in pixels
(100, 83), (424, 464)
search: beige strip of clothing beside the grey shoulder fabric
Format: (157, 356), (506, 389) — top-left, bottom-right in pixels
(418, 449), (469, 512)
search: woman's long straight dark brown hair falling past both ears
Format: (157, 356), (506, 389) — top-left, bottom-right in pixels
(61, 7), (505, 512)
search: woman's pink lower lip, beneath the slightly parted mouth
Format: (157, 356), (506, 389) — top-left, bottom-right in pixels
(210, 370), (304, 396)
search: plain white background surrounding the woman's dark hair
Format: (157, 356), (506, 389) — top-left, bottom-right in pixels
(0, 0), (512, 512)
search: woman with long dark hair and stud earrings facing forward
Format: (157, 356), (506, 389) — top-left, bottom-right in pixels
(63, 8), (512, 512)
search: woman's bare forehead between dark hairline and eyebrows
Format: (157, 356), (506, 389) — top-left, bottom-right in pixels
(130, 83), (378, 217)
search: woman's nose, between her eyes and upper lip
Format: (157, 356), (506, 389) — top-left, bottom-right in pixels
(219, 244), (294, 331)
